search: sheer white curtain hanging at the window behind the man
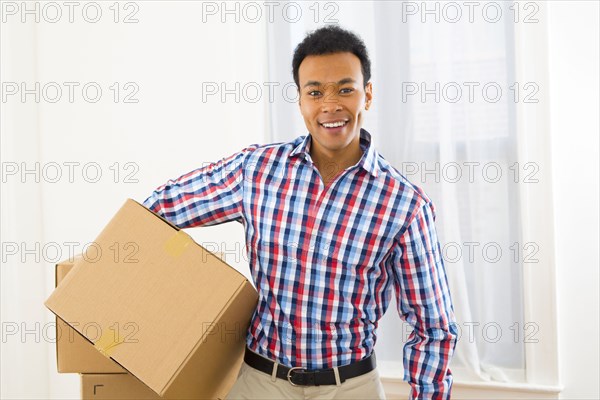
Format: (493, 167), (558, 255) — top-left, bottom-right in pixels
(267, 1), (524, 381)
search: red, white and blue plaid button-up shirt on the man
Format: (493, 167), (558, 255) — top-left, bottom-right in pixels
(144, 129), (457, 399)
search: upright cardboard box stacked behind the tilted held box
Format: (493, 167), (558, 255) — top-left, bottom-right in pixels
(55, 256), (126, 373)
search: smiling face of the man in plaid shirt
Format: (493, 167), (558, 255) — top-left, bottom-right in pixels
(298, 52), (372, 157)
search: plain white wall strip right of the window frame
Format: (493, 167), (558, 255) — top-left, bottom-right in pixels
(548, 1), (600, 399)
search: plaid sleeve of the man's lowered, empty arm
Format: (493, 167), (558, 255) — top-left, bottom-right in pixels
(390, 202), (458, 400)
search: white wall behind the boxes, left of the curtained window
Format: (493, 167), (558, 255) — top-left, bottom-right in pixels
(0, 2), (268, 399)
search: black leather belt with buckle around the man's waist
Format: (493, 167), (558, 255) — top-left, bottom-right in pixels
(244, 346), (377, 386)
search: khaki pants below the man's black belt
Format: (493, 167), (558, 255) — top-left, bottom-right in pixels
(225, 362), (385, 400)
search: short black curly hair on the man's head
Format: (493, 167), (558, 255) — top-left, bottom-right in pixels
(292, 25), (371, 90)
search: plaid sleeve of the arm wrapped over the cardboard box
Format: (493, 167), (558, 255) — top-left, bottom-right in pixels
(143, 144), (258, 228)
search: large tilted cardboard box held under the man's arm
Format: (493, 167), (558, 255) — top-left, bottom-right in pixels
(45, 199), (258, 398)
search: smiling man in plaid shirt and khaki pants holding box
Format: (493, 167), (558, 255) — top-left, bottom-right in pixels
(144, 26), (457, 399)
